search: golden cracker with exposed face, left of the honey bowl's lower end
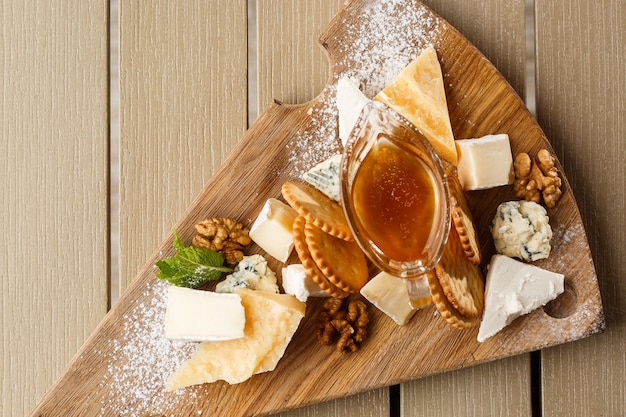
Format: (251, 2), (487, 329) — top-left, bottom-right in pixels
(304, 221), (369, 293)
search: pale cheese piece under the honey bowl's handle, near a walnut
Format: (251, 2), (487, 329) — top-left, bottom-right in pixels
(361, 272), (430, 326)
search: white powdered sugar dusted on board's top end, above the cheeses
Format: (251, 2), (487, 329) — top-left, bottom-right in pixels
(287, 0), (445, 176)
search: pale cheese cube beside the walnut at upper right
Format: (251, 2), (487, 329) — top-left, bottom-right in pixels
(456, 134), (515, 190)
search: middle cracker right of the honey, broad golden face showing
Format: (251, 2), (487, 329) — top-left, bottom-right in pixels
(435, 227), (485, 317)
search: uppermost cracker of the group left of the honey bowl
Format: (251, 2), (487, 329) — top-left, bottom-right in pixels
(281, 181), (354, 240)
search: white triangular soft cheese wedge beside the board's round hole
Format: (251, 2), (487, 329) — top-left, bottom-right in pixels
(478, 255), (564, 342)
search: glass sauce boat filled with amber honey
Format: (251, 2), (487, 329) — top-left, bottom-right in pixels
(341, 102), (450, 282)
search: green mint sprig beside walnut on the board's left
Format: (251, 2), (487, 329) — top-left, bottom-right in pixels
(155, 231), (233, 288)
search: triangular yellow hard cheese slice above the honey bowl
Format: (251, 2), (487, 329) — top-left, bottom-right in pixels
(374, 47), (458, 166)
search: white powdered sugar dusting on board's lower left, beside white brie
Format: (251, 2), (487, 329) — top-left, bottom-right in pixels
(100, 280), (201, 416)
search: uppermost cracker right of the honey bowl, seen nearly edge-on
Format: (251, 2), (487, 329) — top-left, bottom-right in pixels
(448, 175), (481, 265)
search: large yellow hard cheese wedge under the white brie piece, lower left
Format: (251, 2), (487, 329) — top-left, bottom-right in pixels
(167, 288), (306, 391)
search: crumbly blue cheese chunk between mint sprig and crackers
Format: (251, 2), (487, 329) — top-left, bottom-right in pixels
(215, 254), (279, 293)
